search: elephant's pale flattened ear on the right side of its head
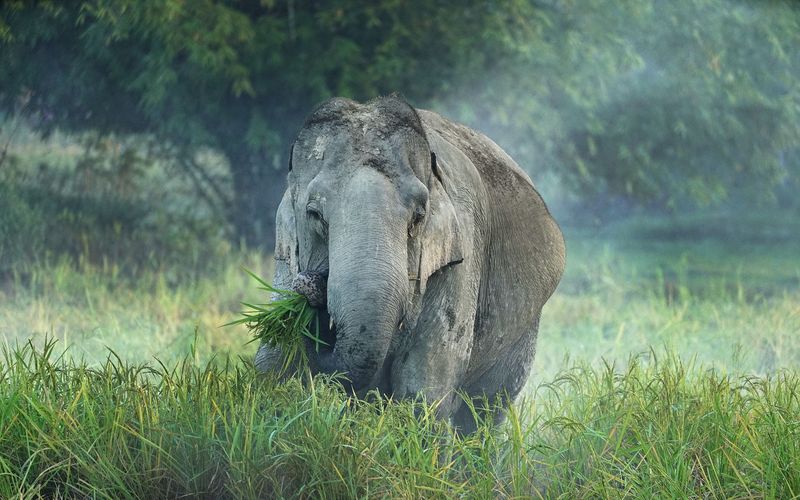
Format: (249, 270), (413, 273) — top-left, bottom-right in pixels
(409, 153), (464, 294)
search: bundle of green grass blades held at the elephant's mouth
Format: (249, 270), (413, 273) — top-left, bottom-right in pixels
(226, 269), (328, 371)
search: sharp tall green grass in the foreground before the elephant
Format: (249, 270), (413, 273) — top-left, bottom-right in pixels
(0, 342), (800, 498)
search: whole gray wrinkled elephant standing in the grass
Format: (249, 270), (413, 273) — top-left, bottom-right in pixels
(256, 97), (565, 432)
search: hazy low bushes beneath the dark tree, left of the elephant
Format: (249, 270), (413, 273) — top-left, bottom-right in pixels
(0, 128), (232, 278)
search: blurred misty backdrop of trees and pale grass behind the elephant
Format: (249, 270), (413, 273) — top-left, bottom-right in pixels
(0, 0), (800, 378)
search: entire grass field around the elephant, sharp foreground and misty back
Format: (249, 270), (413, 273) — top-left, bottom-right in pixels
(0, 212), (800, 498)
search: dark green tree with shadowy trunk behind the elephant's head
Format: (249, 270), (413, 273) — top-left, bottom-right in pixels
(0, 0), (530, 245)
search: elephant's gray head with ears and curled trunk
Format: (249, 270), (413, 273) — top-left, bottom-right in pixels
(277, 98), (462, 390)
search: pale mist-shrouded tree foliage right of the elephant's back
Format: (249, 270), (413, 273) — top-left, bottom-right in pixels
(450, 0), (800, 208)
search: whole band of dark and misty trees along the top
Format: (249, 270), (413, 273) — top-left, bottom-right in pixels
(0, 0), (800, 243)
